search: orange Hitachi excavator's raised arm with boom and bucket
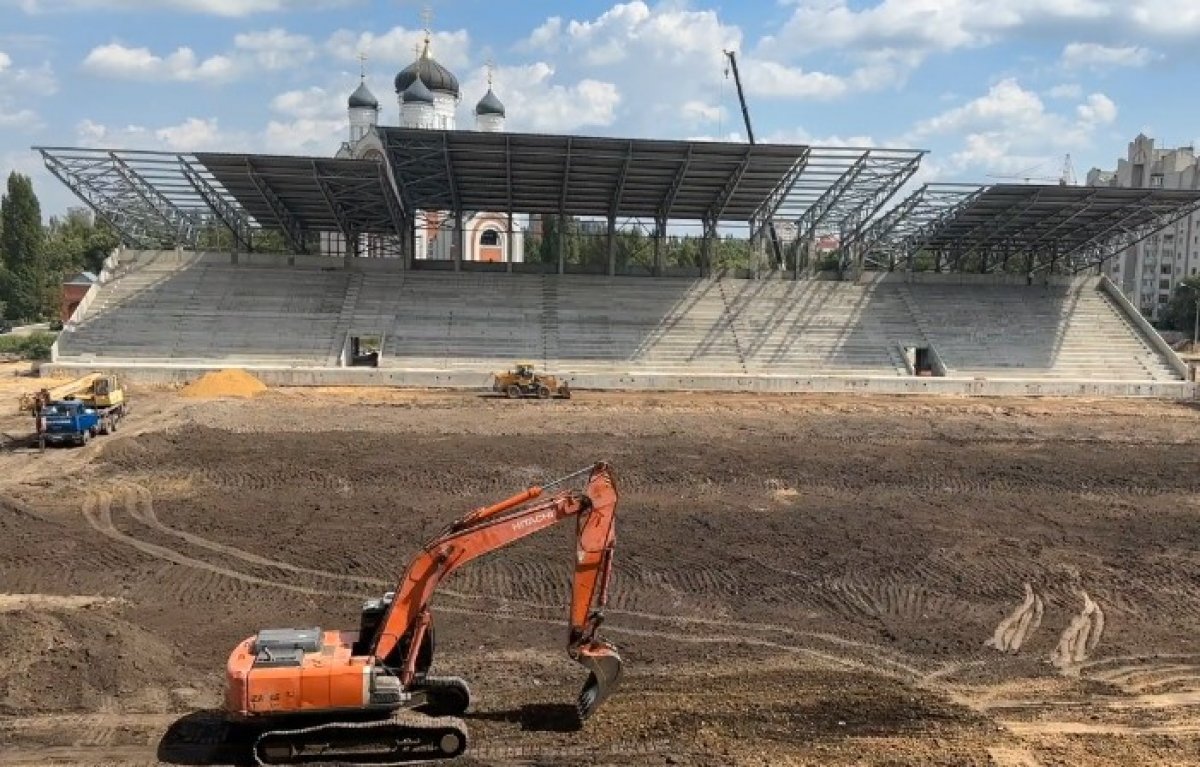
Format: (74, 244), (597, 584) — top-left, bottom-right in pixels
(371, 463), (620, 718)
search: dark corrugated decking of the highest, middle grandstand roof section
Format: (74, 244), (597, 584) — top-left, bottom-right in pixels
(377, 127), (809, 221)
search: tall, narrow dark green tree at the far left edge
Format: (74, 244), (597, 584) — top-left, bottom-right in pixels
(0, 172), (51, 320)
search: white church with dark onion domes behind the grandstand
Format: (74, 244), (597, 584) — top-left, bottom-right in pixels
(335, 30), (524, 263)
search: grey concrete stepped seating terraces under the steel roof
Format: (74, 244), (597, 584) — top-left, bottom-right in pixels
(60, 259), (1178, 380)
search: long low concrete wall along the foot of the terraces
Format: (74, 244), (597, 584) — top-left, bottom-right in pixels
(41, 361), (1200, 400)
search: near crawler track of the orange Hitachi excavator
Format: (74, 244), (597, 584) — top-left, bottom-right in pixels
(254, 711), (467, 767)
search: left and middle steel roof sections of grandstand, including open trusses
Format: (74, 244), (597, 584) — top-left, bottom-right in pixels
(35, 127), (925, 264)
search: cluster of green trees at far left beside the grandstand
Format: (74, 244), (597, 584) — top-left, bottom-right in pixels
(0, 172), (120, 322)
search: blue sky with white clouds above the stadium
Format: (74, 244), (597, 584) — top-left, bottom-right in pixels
(0, 0), (1200, 212)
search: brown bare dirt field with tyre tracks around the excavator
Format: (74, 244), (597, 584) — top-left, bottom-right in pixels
(0, 379), (1200, 767)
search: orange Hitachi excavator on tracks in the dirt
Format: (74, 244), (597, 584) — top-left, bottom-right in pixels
(226, 462), (622, 765)
